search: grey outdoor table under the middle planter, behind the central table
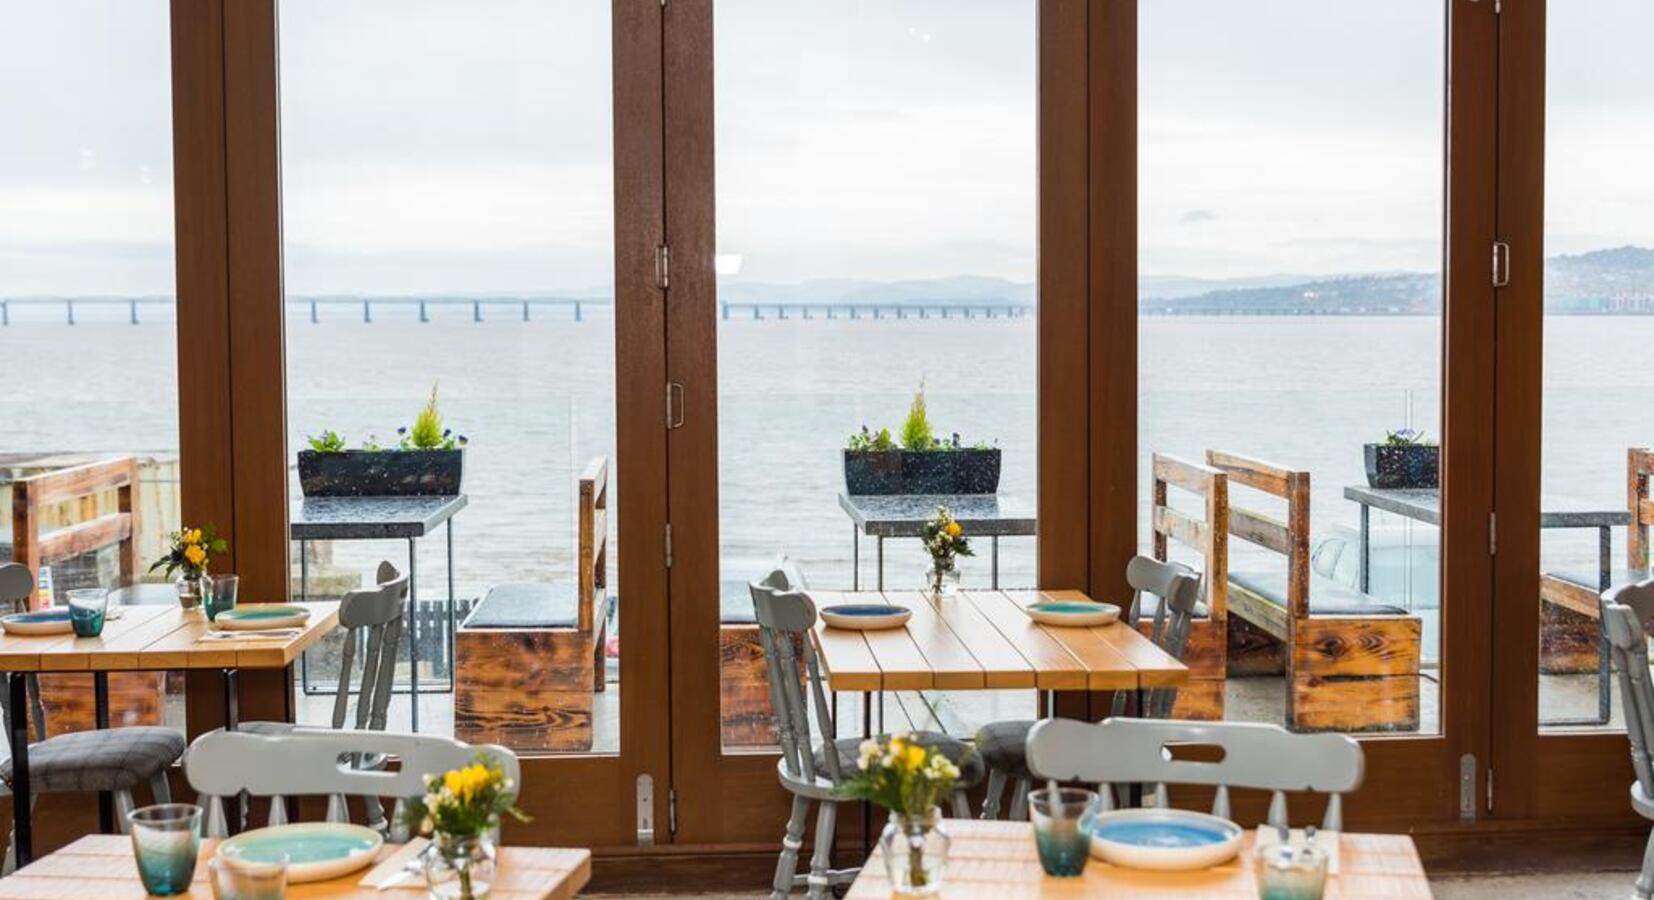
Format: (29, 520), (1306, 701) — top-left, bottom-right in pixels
(839, 491), (1037, 591)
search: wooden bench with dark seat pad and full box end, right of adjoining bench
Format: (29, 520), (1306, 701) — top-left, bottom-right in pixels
(1206, 450), (1422, 731)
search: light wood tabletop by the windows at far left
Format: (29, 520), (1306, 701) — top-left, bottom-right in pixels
(0, 602), (339, 672)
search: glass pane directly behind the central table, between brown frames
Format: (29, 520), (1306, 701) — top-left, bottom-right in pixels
(715, 0), (1037, 751)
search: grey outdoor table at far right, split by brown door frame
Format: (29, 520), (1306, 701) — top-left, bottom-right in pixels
(1345, 485), (1631, 726)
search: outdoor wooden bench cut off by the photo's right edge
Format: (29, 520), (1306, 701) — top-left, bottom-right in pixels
(1540, 447), (1654, 677)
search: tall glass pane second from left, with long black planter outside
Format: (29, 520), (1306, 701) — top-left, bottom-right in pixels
(281, 0), (620, 753)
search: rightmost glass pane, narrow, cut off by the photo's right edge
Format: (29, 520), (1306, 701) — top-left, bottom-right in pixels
(1540, 0), (1654, 728)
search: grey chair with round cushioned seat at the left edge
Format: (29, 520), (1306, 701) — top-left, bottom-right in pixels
(0, 563), (185, 872)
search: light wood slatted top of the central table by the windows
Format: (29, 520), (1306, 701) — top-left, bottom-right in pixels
(809, 591), (1189, 692)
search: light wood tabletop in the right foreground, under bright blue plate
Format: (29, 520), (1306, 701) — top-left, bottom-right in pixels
(846, 819), (1431, 900)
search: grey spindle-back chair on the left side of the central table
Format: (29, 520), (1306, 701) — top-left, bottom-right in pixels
(751, 569), (982, 898)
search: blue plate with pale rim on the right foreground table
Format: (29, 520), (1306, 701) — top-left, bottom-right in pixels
(1092, 809), (1242, 872)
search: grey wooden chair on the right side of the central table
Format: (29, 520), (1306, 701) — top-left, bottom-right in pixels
(976, 556), (1201, 819)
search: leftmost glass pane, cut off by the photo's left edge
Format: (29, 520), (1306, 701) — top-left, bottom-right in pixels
(0, 0), (184, 741)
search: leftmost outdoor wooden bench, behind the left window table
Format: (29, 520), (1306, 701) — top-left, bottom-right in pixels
(12, 457), (165, 735)
